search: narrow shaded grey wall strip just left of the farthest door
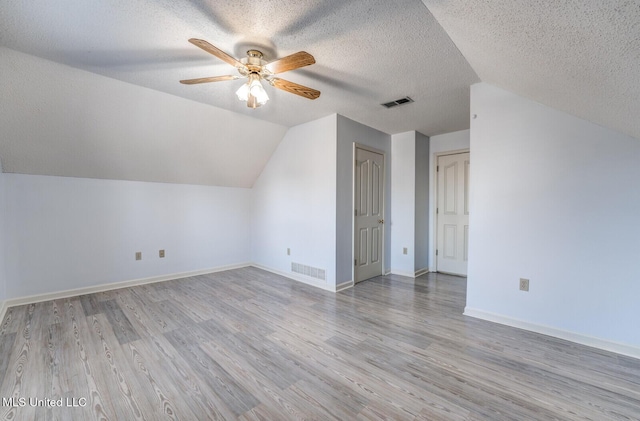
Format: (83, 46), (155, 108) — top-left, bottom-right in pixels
(414, 132), (431, 272)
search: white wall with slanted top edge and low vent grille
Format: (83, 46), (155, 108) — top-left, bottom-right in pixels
(251, 114), (337, 289)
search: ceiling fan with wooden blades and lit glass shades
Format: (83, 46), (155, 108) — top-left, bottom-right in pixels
(180, 38), (320, 108)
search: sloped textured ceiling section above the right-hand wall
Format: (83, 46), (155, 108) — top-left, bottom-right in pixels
(423, 0), (640, 139)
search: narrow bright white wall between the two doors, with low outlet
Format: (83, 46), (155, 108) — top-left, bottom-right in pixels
(390, 131), (416, 276)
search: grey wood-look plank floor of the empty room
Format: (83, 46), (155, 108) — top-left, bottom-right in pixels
(0, 268), (640, 420)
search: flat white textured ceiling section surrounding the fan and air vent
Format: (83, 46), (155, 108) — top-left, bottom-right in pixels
(0, 0), (478, 135)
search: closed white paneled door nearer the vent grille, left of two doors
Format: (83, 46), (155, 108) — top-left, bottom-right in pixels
(354, 148), (384, 282)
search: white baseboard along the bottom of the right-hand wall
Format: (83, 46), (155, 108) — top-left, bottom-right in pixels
(464, 307), (640, 359)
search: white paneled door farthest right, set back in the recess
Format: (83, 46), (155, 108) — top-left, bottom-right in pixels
(436, 152), (469, 276)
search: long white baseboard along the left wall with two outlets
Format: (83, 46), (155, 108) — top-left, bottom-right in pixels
(0, 263), (250, 306)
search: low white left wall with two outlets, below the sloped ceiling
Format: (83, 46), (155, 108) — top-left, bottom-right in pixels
(3, 174), (251, 298)
